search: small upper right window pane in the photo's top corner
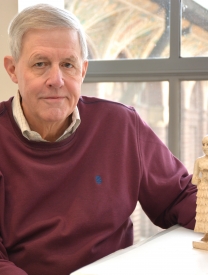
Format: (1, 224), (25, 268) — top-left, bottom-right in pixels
(181, 0), (208, 57)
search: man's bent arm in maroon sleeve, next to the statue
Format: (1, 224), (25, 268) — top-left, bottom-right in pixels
(138, 116), (197, 229)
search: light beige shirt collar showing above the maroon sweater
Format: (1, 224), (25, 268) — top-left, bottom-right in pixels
(12, 91), (81, 142)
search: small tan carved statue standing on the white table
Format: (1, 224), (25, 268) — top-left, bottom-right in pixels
(192, 135), (208, 250)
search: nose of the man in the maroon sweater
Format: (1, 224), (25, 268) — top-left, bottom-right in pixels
(46, 66), (64, 88)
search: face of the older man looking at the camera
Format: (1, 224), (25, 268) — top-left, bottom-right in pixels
(7, 28), (87, 128)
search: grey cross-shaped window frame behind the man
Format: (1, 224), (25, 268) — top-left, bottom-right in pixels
(84, 0), (208, 159)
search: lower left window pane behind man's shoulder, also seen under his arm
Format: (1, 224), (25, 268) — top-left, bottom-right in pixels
(82, 81), (169, 243)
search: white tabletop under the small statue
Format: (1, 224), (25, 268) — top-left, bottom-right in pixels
(71, 226), (208, 275)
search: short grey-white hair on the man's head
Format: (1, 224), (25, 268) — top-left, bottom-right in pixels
(8, 4), (88, 61)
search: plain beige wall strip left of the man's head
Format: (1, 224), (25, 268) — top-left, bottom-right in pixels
(0, 0), (18, 101)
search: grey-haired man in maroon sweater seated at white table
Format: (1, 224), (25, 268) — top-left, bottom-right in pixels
(0, 2), (196, 275)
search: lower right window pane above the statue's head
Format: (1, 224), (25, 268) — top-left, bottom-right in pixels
(181, 81), (208, 173)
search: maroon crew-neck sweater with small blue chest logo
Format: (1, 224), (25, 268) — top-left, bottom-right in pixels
(0, 97), (196, 275)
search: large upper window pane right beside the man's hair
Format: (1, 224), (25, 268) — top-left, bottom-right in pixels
(65, 0), (170, 60)
